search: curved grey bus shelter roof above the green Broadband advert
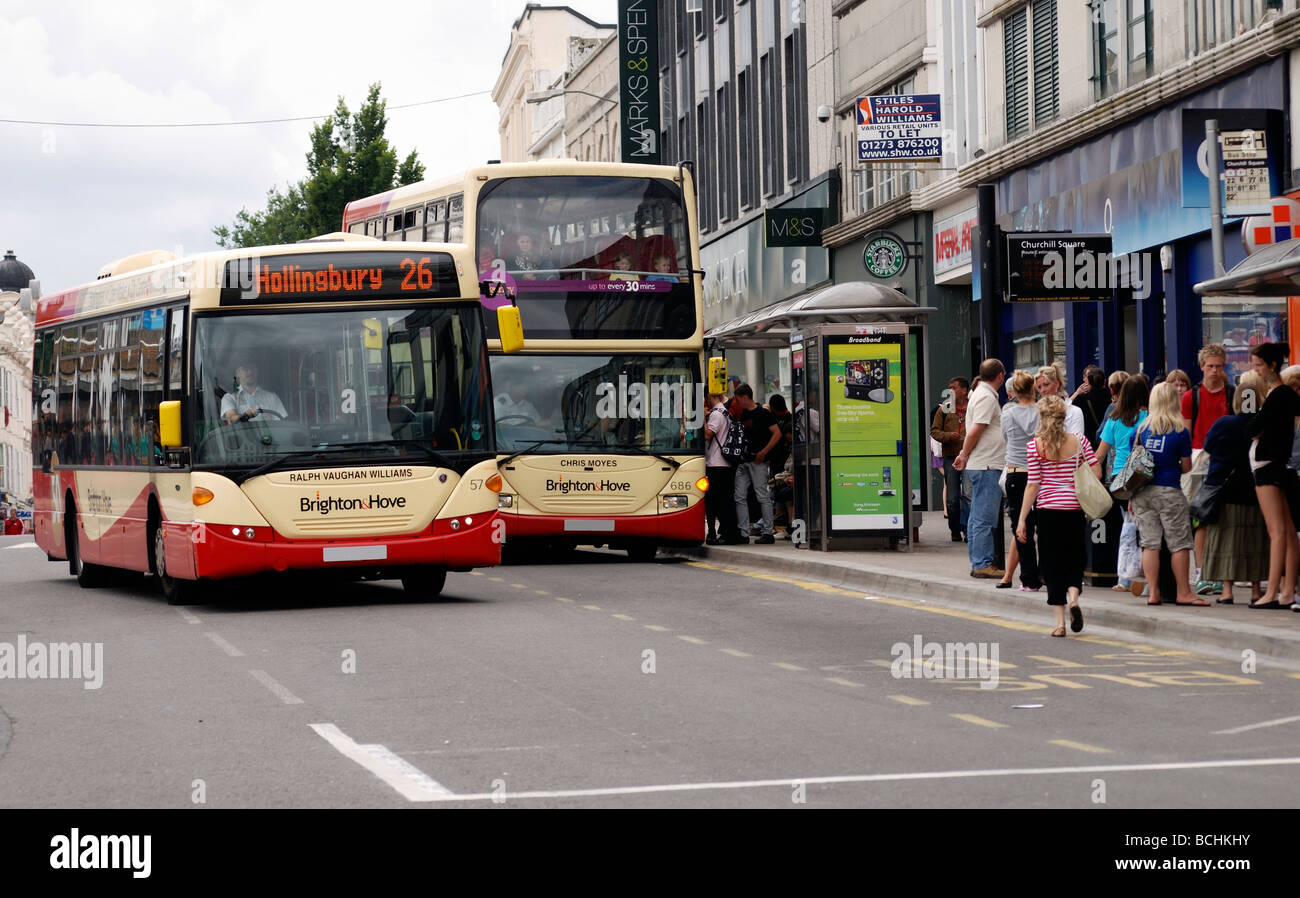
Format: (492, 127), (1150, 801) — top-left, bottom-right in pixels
(705, 281), (939, 350)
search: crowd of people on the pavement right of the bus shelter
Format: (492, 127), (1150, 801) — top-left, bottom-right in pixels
(931, 343), (1300, 637)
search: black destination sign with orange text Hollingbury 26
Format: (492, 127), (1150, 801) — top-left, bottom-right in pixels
(221, 252), (460, 305)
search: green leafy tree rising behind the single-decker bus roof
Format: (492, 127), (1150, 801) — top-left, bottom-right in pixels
(212, 83), (424, 248)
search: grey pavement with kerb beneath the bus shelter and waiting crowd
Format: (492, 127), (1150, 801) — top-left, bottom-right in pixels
(671, 512), (1300, 671)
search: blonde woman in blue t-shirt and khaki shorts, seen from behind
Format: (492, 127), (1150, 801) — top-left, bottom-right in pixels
(1131, 382), (1196, 606)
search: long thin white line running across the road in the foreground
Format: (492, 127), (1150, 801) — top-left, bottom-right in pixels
(408, 758), (1300, 802)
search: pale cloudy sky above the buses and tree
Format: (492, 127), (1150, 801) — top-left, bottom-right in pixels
(0, 0), (616, 294)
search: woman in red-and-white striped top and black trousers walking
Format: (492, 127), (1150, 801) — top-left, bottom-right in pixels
(1015, 396), (1101, 635)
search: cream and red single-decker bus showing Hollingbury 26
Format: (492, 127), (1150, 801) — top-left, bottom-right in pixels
(33, 234), (503, 604)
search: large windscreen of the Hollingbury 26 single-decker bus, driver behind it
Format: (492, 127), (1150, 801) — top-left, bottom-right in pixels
(191, 304), (493, 469)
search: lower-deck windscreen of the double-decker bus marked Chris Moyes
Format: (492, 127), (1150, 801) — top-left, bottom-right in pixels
(491, 353), (705, 454)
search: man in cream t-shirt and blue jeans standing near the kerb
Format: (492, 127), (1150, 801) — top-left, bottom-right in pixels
(953, 359), (1006, 580)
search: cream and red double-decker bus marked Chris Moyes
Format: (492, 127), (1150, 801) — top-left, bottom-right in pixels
(343, 161), (709, 560)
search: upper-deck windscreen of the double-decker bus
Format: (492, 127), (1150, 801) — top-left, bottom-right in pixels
(477, 175), (697, 339)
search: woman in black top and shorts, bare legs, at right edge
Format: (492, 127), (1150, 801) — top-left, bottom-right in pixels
(1247, 343), (1300, 608)
